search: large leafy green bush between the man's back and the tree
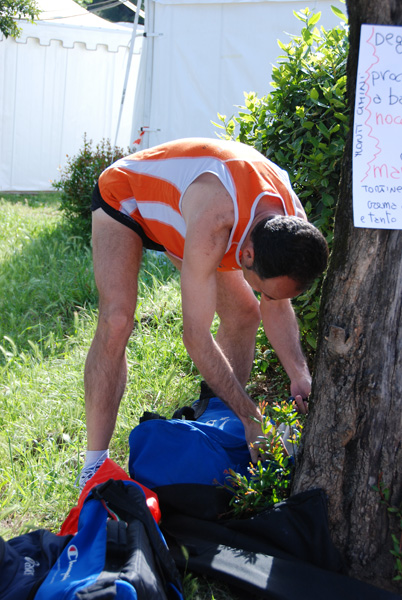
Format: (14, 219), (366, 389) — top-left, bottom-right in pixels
(216, 8), (348, 351)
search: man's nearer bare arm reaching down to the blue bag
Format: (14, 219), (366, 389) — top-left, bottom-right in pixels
(181, 178), (262, 460)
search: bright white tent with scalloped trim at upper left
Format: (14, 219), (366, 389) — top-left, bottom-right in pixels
(0, 0), (142, 191)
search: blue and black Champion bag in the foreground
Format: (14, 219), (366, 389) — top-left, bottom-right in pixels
(35, 479), (183, 600)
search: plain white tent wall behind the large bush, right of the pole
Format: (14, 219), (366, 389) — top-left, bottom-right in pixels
(132, 0), (345, 146)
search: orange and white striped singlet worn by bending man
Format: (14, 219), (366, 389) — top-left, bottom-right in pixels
(99, 138), (296, 271)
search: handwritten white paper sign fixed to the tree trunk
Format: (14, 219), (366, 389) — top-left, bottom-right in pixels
(353, 25), (402, 229)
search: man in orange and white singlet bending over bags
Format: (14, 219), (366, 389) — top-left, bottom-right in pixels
(80, 138), (328, 487)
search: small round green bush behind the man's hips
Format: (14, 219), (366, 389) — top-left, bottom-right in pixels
(53, 134), (128, 242)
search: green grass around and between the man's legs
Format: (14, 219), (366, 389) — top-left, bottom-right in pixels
(0, 194), (290, 600)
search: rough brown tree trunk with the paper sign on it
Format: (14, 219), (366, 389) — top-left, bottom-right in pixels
(293, 0), (402, 593)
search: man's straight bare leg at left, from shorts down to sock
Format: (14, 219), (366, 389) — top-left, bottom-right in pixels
(84, 209), (142, 458)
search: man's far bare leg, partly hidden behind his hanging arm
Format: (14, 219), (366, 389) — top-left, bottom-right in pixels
(216, 271), (261, 386)
